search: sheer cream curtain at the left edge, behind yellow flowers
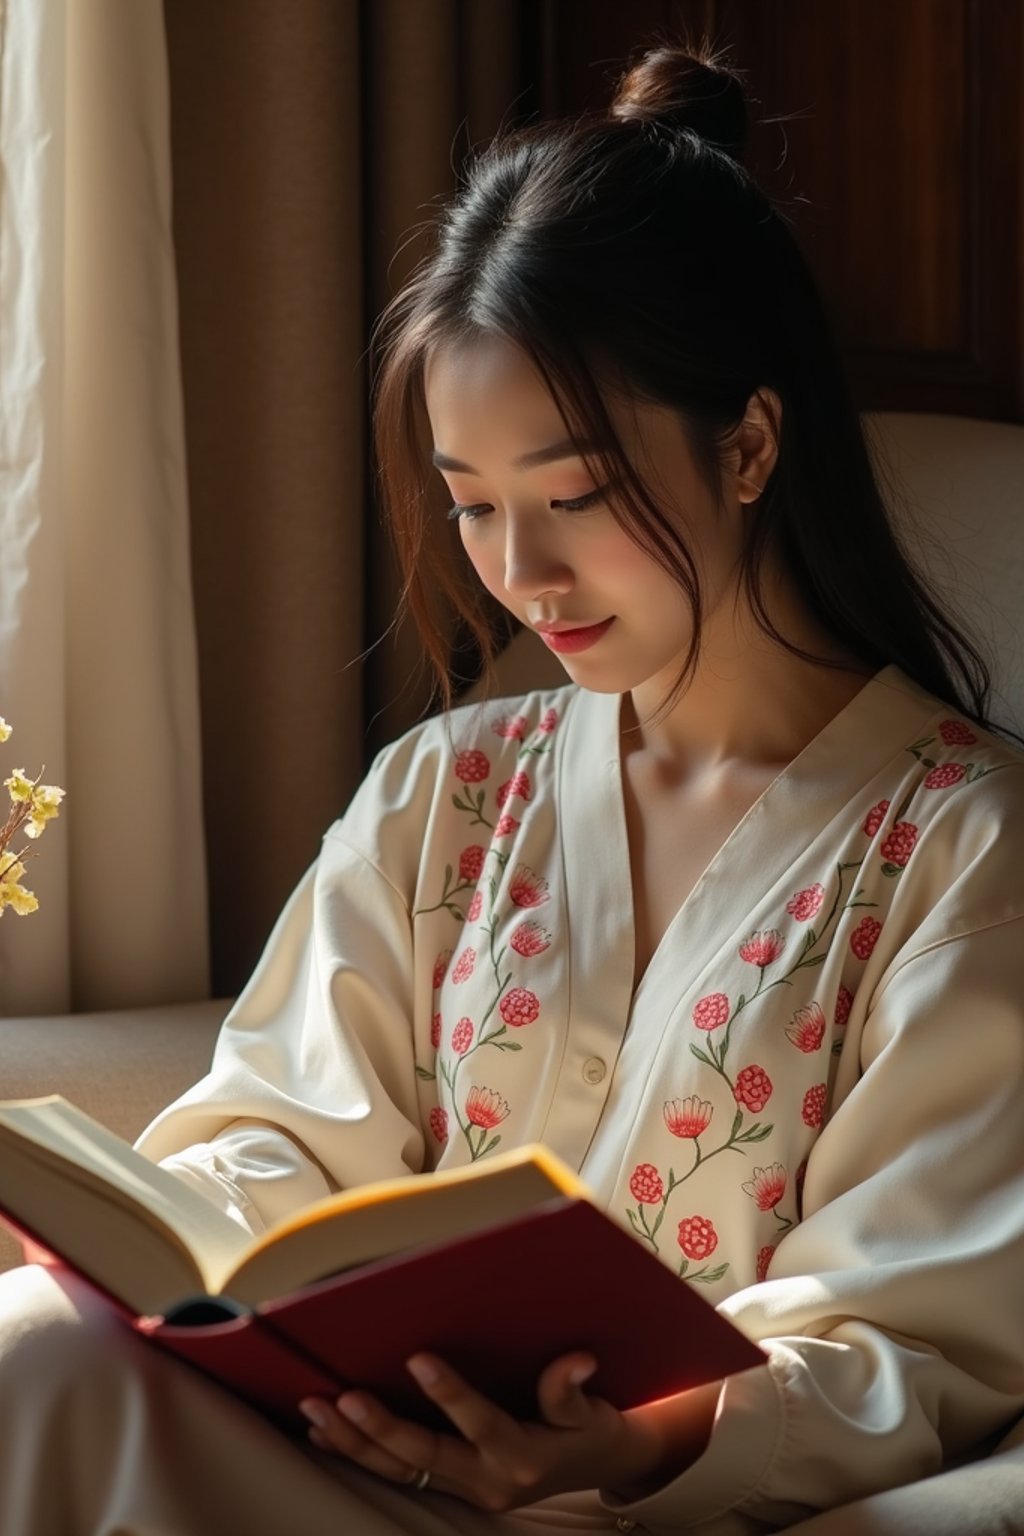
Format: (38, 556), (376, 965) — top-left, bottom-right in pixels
(0, 0), (207, 1015)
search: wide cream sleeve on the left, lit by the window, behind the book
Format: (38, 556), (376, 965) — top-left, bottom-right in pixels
(137, 731), (434, 1232)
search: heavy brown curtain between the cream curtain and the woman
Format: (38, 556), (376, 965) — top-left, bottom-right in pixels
(164, 0), (539, 995)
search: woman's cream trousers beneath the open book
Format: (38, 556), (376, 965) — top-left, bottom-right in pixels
(0, 1266), (1024, 1536)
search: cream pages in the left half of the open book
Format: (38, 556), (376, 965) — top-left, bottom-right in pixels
(0, 1095), (252, 1312)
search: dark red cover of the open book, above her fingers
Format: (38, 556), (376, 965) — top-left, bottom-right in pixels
(138, 1198), (765, 1425)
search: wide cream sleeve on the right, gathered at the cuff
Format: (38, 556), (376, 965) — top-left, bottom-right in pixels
(605, 891), (1024, 1536)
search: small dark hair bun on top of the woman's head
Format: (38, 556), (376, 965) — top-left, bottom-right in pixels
(609, 48), (749, 160)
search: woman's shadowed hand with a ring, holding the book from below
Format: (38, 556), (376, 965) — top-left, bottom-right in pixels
(301, 1355), (720, 1511)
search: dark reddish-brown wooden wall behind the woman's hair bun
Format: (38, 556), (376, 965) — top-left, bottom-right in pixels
(539, 0), (1024, 421)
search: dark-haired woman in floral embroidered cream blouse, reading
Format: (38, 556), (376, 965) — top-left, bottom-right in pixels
(0, 49), (1024, 1536)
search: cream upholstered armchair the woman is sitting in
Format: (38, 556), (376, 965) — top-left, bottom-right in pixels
(0, 413), (1024, 1536)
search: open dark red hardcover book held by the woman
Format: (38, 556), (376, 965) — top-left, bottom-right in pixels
(0, 1097), (765, 1422)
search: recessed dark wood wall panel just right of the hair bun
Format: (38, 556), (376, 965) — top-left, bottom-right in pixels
(739, 0), (970, 353)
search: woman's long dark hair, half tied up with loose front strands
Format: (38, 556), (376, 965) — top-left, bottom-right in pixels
(375, 48), (990, 723)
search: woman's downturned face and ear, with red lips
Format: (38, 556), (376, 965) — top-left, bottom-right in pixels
(425, 336), (743, 693)
